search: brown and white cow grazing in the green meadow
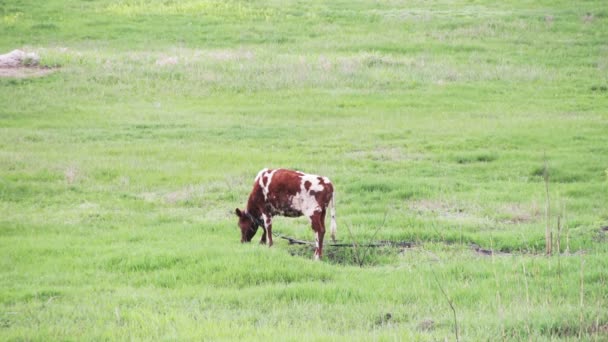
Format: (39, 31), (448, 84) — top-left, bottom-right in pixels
(236, 169), (336, 259)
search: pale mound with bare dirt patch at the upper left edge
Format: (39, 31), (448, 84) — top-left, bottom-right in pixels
(0, 50), (54, 78)
